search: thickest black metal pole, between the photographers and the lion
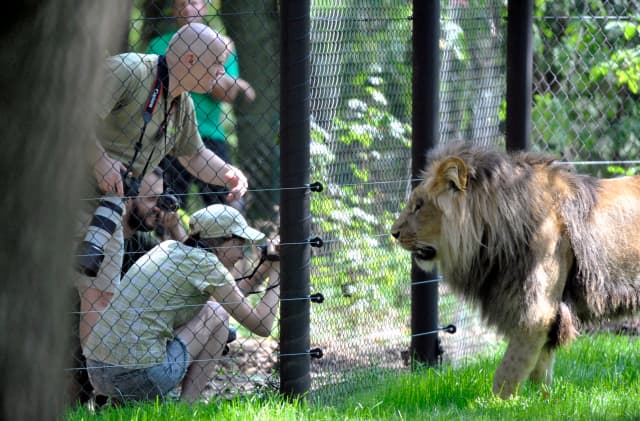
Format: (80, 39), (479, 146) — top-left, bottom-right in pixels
(280, 0), (311, 398)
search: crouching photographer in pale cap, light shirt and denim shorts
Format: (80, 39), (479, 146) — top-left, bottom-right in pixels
(85, 204), (280, 402)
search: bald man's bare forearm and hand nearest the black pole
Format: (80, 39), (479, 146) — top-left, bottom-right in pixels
(178, 148), (248, 200)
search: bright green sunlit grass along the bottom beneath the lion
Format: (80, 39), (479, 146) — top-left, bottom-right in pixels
(66, 334), (640, 421)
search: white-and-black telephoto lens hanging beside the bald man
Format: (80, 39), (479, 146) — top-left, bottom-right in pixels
(76, 196), (124, 278)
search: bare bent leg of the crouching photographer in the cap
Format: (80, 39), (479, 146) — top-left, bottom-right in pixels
(176, 301), (229, 402)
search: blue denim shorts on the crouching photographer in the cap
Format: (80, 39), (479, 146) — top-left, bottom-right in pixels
(87, 338), (189, 401)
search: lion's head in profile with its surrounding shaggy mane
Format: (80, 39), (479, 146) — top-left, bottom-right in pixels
(391, 143), (555, 291)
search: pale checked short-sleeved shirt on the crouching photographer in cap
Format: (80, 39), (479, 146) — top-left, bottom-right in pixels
(84, 240), (235, 368)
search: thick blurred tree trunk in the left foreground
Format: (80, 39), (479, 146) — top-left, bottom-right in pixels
(0, 0), (129, 420)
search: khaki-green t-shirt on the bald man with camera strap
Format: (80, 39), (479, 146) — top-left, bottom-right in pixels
(96, 53), (204, 175)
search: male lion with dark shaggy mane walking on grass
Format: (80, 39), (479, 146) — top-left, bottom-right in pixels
(391, 143), (640, 398)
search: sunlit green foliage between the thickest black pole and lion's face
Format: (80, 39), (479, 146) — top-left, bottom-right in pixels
(310, 68), (410, 324)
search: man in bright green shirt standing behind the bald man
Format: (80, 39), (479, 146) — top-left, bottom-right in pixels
(147, 0), (255, 207)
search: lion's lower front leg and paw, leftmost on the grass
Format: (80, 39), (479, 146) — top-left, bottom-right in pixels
(493, 332), (547, 399)
